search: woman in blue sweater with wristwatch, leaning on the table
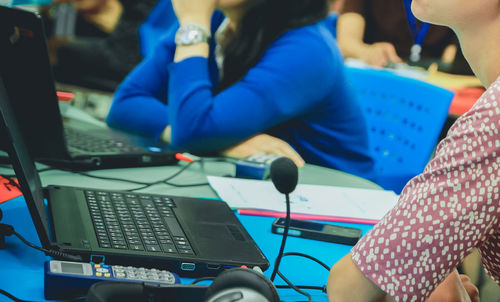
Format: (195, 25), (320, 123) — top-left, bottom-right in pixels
(107, 0), (373, 178)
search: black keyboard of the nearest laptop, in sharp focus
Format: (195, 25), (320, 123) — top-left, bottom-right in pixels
(85, 191), (194, 255)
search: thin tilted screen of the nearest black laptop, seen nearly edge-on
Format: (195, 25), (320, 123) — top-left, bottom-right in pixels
(0, 76), (50, 248)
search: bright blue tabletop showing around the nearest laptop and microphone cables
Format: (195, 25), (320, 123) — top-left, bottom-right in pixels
(0, 197), (371, 301)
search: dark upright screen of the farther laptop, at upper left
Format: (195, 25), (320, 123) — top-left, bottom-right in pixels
(0, 6), (67, 158)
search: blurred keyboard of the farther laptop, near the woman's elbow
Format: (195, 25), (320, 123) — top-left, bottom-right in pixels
(64, 128), (143, 153)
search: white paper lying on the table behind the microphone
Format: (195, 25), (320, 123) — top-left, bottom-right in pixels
(208, 176), (398, 220)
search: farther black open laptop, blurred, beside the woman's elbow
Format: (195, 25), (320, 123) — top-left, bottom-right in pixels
(0, 6), (177, 169)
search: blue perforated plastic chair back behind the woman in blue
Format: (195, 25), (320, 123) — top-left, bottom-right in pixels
(346, 66), (453, 194)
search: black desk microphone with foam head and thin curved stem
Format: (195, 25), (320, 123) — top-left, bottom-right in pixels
(270, 157), (299, 281)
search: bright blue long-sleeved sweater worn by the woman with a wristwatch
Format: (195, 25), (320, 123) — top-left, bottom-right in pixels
(107, 13), (373, 179)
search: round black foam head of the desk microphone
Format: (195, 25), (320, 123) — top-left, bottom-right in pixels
(271, 157), (299, 194)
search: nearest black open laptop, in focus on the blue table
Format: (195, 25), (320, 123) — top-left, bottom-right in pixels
(0, 77), (269, 276)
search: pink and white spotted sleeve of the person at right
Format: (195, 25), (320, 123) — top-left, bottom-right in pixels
(351, 78), (500, 301)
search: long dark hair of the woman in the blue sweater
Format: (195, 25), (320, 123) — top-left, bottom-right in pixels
(214, 0), (328, 94)
